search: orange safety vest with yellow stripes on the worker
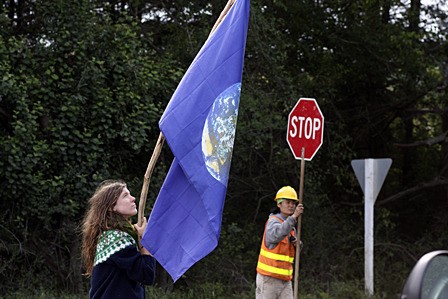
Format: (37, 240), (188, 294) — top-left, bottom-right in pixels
(257, 216), (295, 281)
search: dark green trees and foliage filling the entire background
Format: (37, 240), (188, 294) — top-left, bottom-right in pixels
(0, 0), (448, 298)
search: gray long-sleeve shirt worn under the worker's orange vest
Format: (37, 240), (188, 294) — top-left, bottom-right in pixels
(266, 213), (296, 249)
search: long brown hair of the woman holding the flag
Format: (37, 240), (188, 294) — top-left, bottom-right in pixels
(82, 180), (129, 276)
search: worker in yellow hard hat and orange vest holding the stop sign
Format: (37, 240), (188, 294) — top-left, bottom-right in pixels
(255, 186), (303, 299)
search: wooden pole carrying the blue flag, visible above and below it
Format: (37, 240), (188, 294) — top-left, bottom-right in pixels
(137, 0), (236, 226)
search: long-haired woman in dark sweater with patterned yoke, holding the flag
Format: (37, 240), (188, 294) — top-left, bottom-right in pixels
(82, 181), (156, 299)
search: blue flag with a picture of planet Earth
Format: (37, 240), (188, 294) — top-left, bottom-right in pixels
(142, 0), (250, 281)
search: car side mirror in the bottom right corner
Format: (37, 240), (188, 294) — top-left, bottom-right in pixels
(401, 250), (448, 299)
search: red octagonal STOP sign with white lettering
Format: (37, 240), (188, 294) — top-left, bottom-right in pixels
(286, 98), (324, 161)
